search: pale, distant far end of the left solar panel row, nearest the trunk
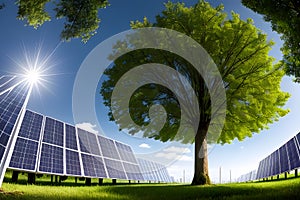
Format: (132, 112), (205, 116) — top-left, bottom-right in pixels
(138, 158), (173, 183)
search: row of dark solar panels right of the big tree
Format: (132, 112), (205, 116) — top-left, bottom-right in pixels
(239, 133), (300, 182)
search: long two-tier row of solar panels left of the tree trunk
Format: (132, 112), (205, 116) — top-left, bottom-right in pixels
(9, 110), (171, 182)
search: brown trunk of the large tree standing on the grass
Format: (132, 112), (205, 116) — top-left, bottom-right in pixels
(192, 125), (210, 185)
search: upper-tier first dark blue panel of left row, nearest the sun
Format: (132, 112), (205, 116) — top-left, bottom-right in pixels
(19, 110), (43, 141)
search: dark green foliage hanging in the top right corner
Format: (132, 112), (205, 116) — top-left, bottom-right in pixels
(242, 0), (300, 77)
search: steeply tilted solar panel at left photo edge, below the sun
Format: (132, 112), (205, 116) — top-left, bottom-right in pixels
(0, 76), (29, 186)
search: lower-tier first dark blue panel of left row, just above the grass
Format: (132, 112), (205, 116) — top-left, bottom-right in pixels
(9, 138), (38, 170)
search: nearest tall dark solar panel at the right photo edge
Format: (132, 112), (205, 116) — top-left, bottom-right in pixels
(286, 138), (300, 170)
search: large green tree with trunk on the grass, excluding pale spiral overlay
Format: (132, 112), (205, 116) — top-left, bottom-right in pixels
(101, 1), (289, 185)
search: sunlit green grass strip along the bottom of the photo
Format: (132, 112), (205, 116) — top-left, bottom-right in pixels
(0, 171), (300, 200)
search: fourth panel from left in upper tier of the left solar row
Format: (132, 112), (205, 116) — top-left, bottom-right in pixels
(77, 128), (101, 155)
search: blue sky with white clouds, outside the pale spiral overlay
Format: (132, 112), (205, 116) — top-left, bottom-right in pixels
(0, 0), (300, 182)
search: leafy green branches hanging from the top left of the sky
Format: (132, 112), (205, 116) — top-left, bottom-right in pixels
(16, 0), (108, 42)
